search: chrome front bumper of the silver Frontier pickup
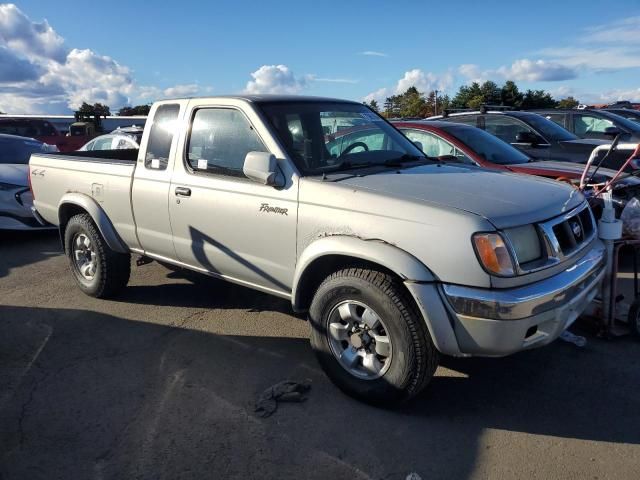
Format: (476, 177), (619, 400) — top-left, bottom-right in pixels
(414, 241), (605, 356)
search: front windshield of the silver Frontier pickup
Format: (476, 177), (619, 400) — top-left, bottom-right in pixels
(260, 101), (426, 175)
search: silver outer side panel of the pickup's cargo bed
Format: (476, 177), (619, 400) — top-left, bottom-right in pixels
(29, 150), (138, 248)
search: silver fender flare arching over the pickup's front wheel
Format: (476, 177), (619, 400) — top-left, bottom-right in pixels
(291, 235), (435, 311)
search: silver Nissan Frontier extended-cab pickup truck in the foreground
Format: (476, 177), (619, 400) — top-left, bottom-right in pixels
(30, 96), (603, 404)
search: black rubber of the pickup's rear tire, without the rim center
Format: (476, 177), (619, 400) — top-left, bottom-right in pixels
(64, 213), (131, 298)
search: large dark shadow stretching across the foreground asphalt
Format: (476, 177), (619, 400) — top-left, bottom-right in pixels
(0, 302), (640, 479)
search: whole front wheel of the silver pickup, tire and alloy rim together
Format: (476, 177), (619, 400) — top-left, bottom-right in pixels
(309, 268), (438, 406)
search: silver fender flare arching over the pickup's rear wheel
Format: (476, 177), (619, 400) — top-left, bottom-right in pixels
(58, 193), (129, 253)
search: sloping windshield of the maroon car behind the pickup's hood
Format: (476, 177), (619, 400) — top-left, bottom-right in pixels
(440, 124), (530, 165)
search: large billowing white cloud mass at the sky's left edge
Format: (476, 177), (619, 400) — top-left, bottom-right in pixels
(0, 4), (215, 113)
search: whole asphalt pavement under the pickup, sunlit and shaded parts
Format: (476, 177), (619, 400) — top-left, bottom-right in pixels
(0, 232), (640, 480)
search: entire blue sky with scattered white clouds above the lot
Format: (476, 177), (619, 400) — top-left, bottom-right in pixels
(0, 0), (640, 113)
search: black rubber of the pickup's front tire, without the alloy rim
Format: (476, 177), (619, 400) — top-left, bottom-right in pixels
(309, 268), (439, 406)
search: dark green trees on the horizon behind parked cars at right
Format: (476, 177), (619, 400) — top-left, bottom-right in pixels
(364, 80), (579, 118)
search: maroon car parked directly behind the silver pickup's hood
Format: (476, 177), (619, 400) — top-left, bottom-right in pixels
(394, 121), (637, 183)
